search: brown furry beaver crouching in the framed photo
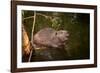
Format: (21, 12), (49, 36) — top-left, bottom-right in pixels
(33, 28), (69, 48)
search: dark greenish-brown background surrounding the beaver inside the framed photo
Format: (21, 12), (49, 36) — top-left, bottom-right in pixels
(22, 11), (90, 61)
